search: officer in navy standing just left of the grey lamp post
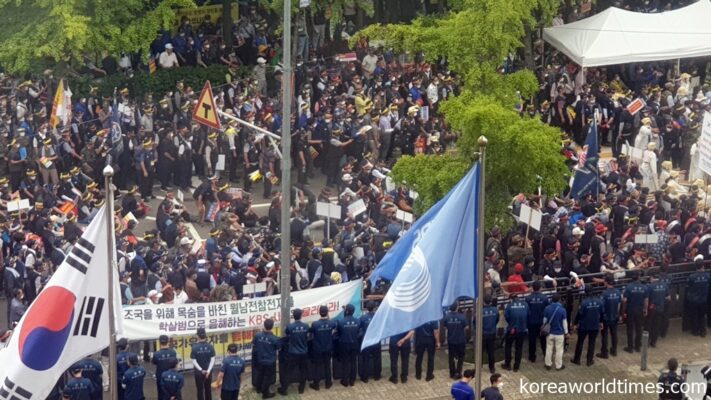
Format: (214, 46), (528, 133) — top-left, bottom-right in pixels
(252, 319), (279, 399)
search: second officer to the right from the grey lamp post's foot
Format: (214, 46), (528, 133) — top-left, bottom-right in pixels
(309, 306), (337, 390)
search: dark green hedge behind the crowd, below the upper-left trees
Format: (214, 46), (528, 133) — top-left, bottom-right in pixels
(69, 65), (249, 98)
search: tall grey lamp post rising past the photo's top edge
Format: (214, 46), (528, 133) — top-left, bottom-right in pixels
(279, 0), (293, 335)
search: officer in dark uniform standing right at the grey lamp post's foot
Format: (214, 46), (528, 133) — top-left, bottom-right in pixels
(279, 308), (309, 396)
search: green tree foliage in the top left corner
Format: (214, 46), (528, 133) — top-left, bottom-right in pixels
(0, 0), (195, 73)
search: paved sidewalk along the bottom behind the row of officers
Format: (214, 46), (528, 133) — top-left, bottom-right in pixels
(231, 320), (711, 400)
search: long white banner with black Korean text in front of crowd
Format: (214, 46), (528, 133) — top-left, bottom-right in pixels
(122, 280), (363, 340)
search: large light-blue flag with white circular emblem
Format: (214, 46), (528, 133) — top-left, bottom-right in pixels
(362, 163), (480, 348)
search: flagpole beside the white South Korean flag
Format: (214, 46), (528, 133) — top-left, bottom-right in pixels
(104, 162), (118, 399)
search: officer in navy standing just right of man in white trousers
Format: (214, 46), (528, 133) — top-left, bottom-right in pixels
(571, 286), (605, 367)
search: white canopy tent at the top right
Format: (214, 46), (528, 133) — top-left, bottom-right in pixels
(543, 0), (711, 67)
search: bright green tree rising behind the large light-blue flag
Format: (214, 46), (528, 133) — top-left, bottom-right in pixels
(353, 0), (567, 226)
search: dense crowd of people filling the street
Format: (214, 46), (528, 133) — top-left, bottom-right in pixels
(0, 0), (711, 399)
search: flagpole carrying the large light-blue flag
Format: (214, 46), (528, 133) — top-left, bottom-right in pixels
(474, 136), (489, 393)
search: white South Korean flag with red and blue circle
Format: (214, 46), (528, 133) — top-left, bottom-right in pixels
(0, 206), (121, 400)
